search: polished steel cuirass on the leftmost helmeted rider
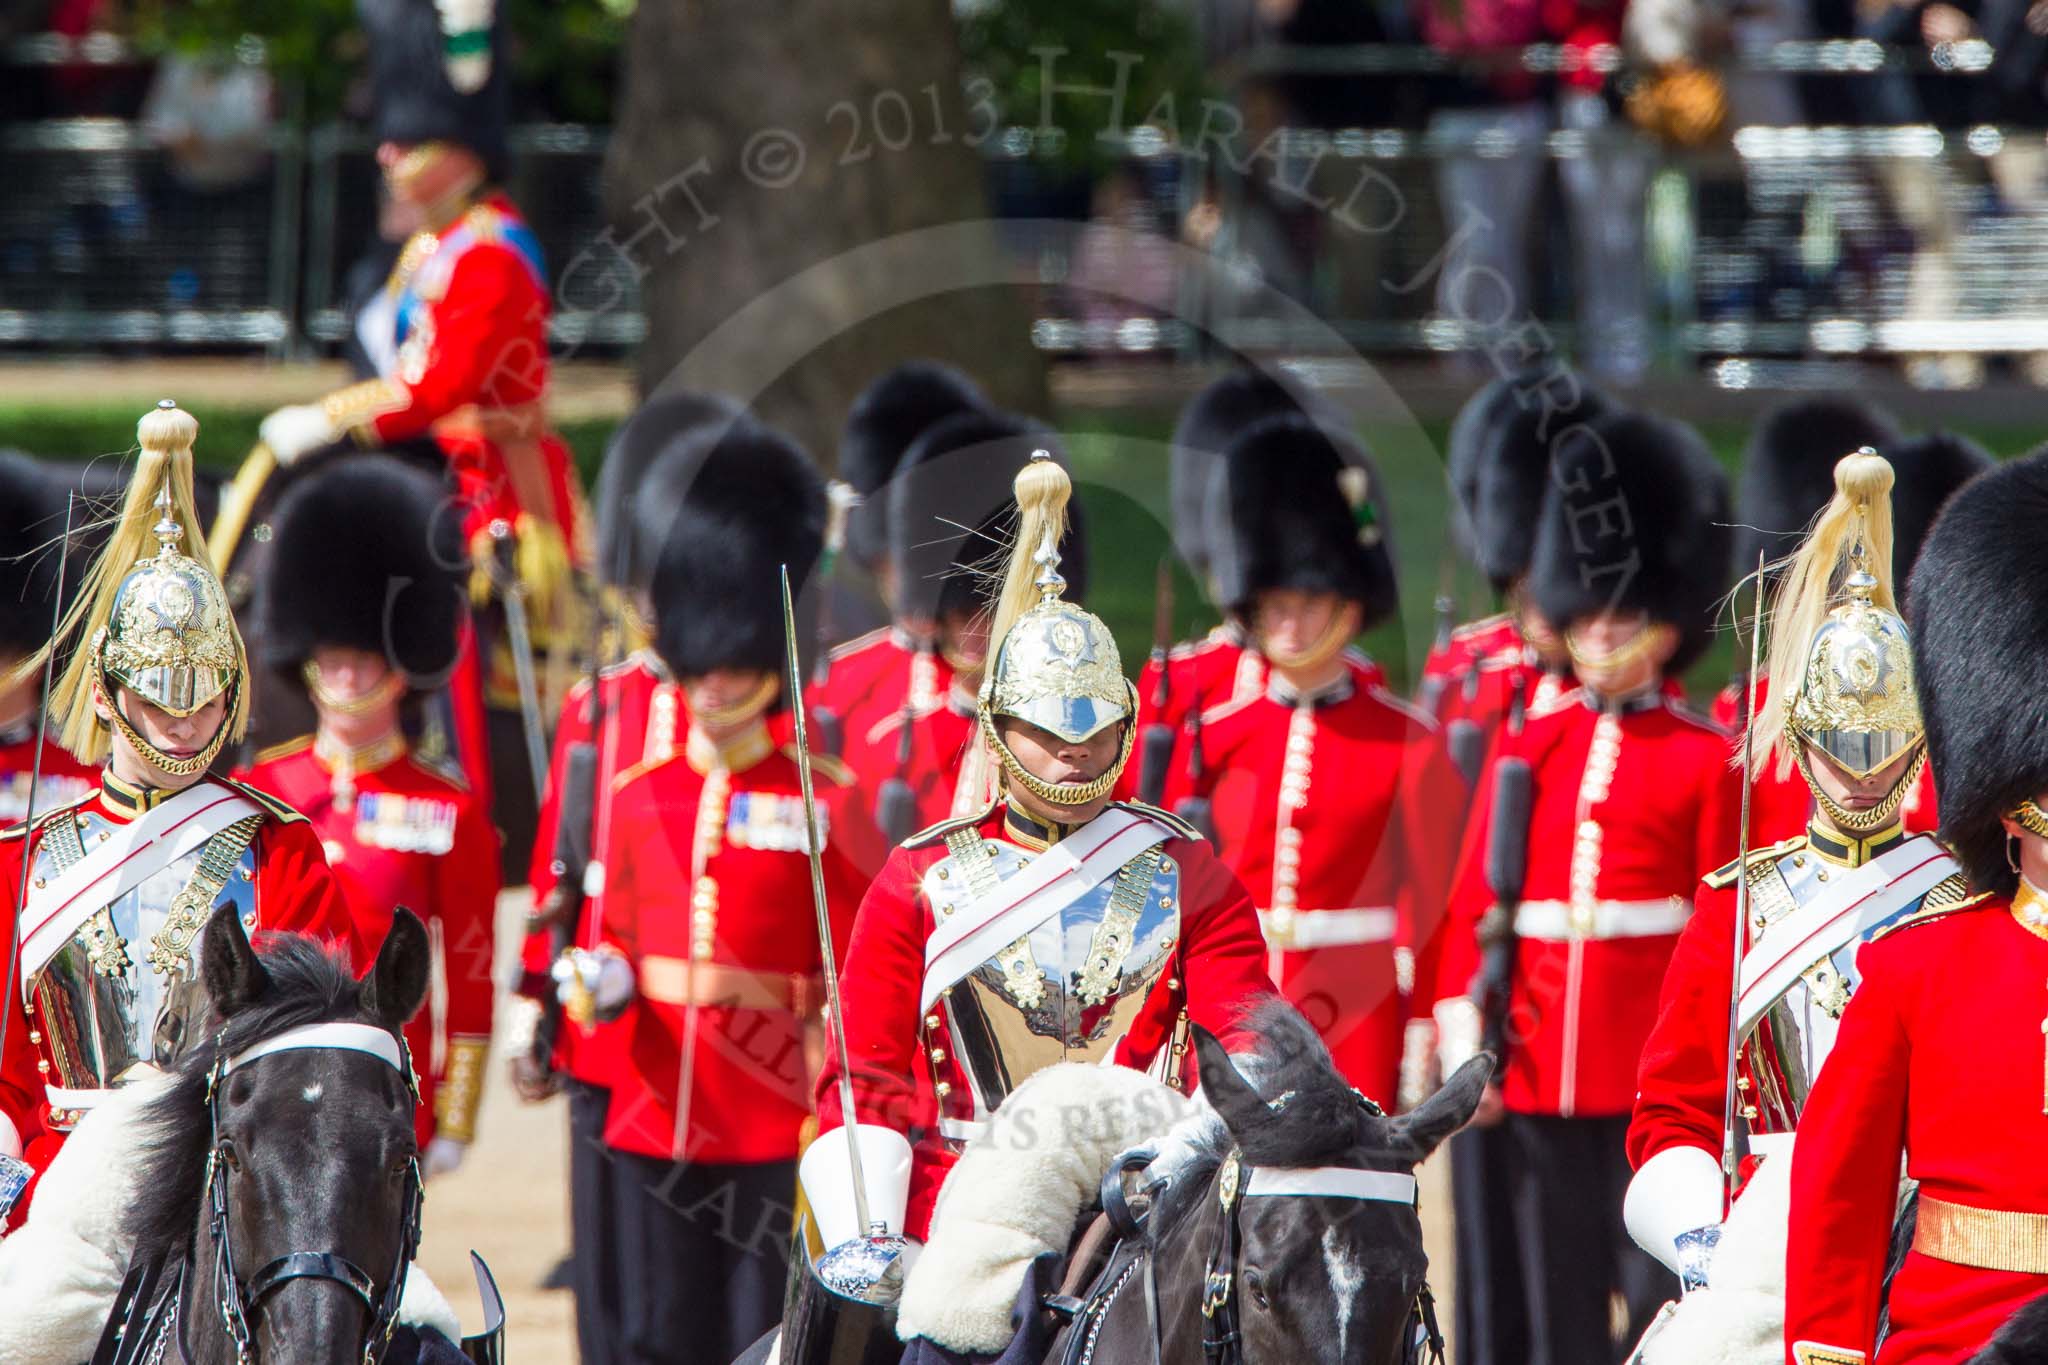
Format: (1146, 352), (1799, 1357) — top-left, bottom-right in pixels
(27, 804), (260, 1109)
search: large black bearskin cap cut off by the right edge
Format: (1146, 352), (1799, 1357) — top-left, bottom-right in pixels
(1907, 448), (2048, 892)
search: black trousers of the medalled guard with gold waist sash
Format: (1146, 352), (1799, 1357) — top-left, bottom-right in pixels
(612, 1152), (797, 1365)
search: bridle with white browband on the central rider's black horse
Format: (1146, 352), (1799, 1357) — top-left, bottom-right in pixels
(1202, 1148), (1444, 1365)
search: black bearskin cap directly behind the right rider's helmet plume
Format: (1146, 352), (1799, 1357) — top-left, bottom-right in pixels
(1731, 395), (1900, 581)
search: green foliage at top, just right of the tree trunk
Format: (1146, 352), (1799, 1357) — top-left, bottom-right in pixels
(961, 0), (1204, 172)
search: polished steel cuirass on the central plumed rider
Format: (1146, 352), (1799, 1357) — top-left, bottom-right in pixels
(924, 831), (1180, 1119)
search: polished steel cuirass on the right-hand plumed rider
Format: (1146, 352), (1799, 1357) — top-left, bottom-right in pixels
(1743, 847), (1933, 1134)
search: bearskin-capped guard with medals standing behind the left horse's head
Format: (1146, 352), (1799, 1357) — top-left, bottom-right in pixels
(236, 456), (498, 1177)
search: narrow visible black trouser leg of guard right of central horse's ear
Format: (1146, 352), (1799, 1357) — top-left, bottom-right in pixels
(1450, 1126), (1530, 1365)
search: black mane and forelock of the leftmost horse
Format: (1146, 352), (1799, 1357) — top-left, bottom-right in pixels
(123, 933), (362, 1263)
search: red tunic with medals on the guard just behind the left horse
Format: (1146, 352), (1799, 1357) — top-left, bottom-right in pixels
(248, 735), (498, 1148)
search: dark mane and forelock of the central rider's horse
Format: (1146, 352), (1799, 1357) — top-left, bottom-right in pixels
(1149, 999), (1384, 1236)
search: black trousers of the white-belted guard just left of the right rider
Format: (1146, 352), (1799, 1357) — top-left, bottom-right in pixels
(1505, 1113), (1677, 1365)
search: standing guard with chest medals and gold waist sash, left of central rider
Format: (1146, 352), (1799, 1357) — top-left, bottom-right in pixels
(557, 422), (881, 1365)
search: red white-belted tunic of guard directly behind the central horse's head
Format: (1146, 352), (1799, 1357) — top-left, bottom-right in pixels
(1167, 675), (1464, 1109)
